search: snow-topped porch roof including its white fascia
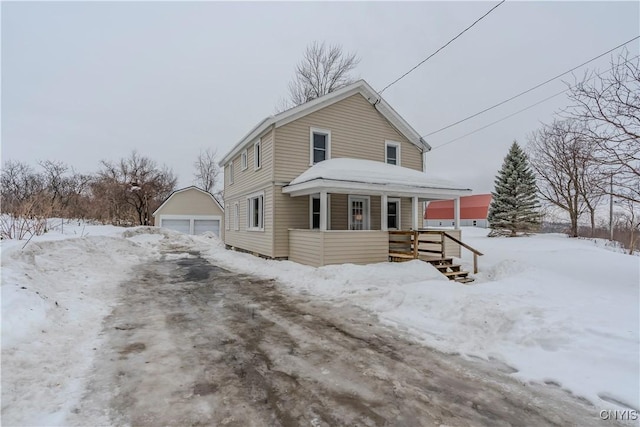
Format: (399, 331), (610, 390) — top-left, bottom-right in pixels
(282, 158), (471, 200)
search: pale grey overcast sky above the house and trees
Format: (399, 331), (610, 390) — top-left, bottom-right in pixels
(1, 1), (640, 192)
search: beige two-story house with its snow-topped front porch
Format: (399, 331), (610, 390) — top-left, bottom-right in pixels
(220, 80), (470, 266)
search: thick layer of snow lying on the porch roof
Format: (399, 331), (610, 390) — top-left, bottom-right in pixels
(289, 158), (462, 190)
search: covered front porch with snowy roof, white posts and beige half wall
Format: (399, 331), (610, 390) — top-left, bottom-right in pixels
(282, 159), (471, 266)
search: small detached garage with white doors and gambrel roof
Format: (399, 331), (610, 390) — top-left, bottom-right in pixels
(153, 186), (224, 238)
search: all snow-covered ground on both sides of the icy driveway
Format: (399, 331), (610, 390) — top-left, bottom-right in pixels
(1, 223), (640, 425)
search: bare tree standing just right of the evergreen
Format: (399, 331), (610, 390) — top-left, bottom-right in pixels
(528, 120), (604, 237)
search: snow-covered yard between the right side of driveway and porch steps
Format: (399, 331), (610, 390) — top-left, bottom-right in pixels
(198, 227), (640, 409)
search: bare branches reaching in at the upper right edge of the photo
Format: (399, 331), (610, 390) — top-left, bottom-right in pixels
(564, 51), (640, 203)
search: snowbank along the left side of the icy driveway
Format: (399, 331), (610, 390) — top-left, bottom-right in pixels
(1, 223), (165, 425)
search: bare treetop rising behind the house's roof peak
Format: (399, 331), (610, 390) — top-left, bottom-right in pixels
(277, 41), (360, 110)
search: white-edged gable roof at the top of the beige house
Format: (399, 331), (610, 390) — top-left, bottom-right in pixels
(219, 80), (431, 166)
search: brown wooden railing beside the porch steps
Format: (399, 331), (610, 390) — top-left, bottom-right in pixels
(389, 230), (483, 274)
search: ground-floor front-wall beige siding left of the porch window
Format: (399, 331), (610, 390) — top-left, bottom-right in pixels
(274, 186), (310, 258)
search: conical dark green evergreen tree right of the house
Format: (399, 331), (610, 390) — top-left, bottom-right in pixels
(487, 141), (540, 236)
